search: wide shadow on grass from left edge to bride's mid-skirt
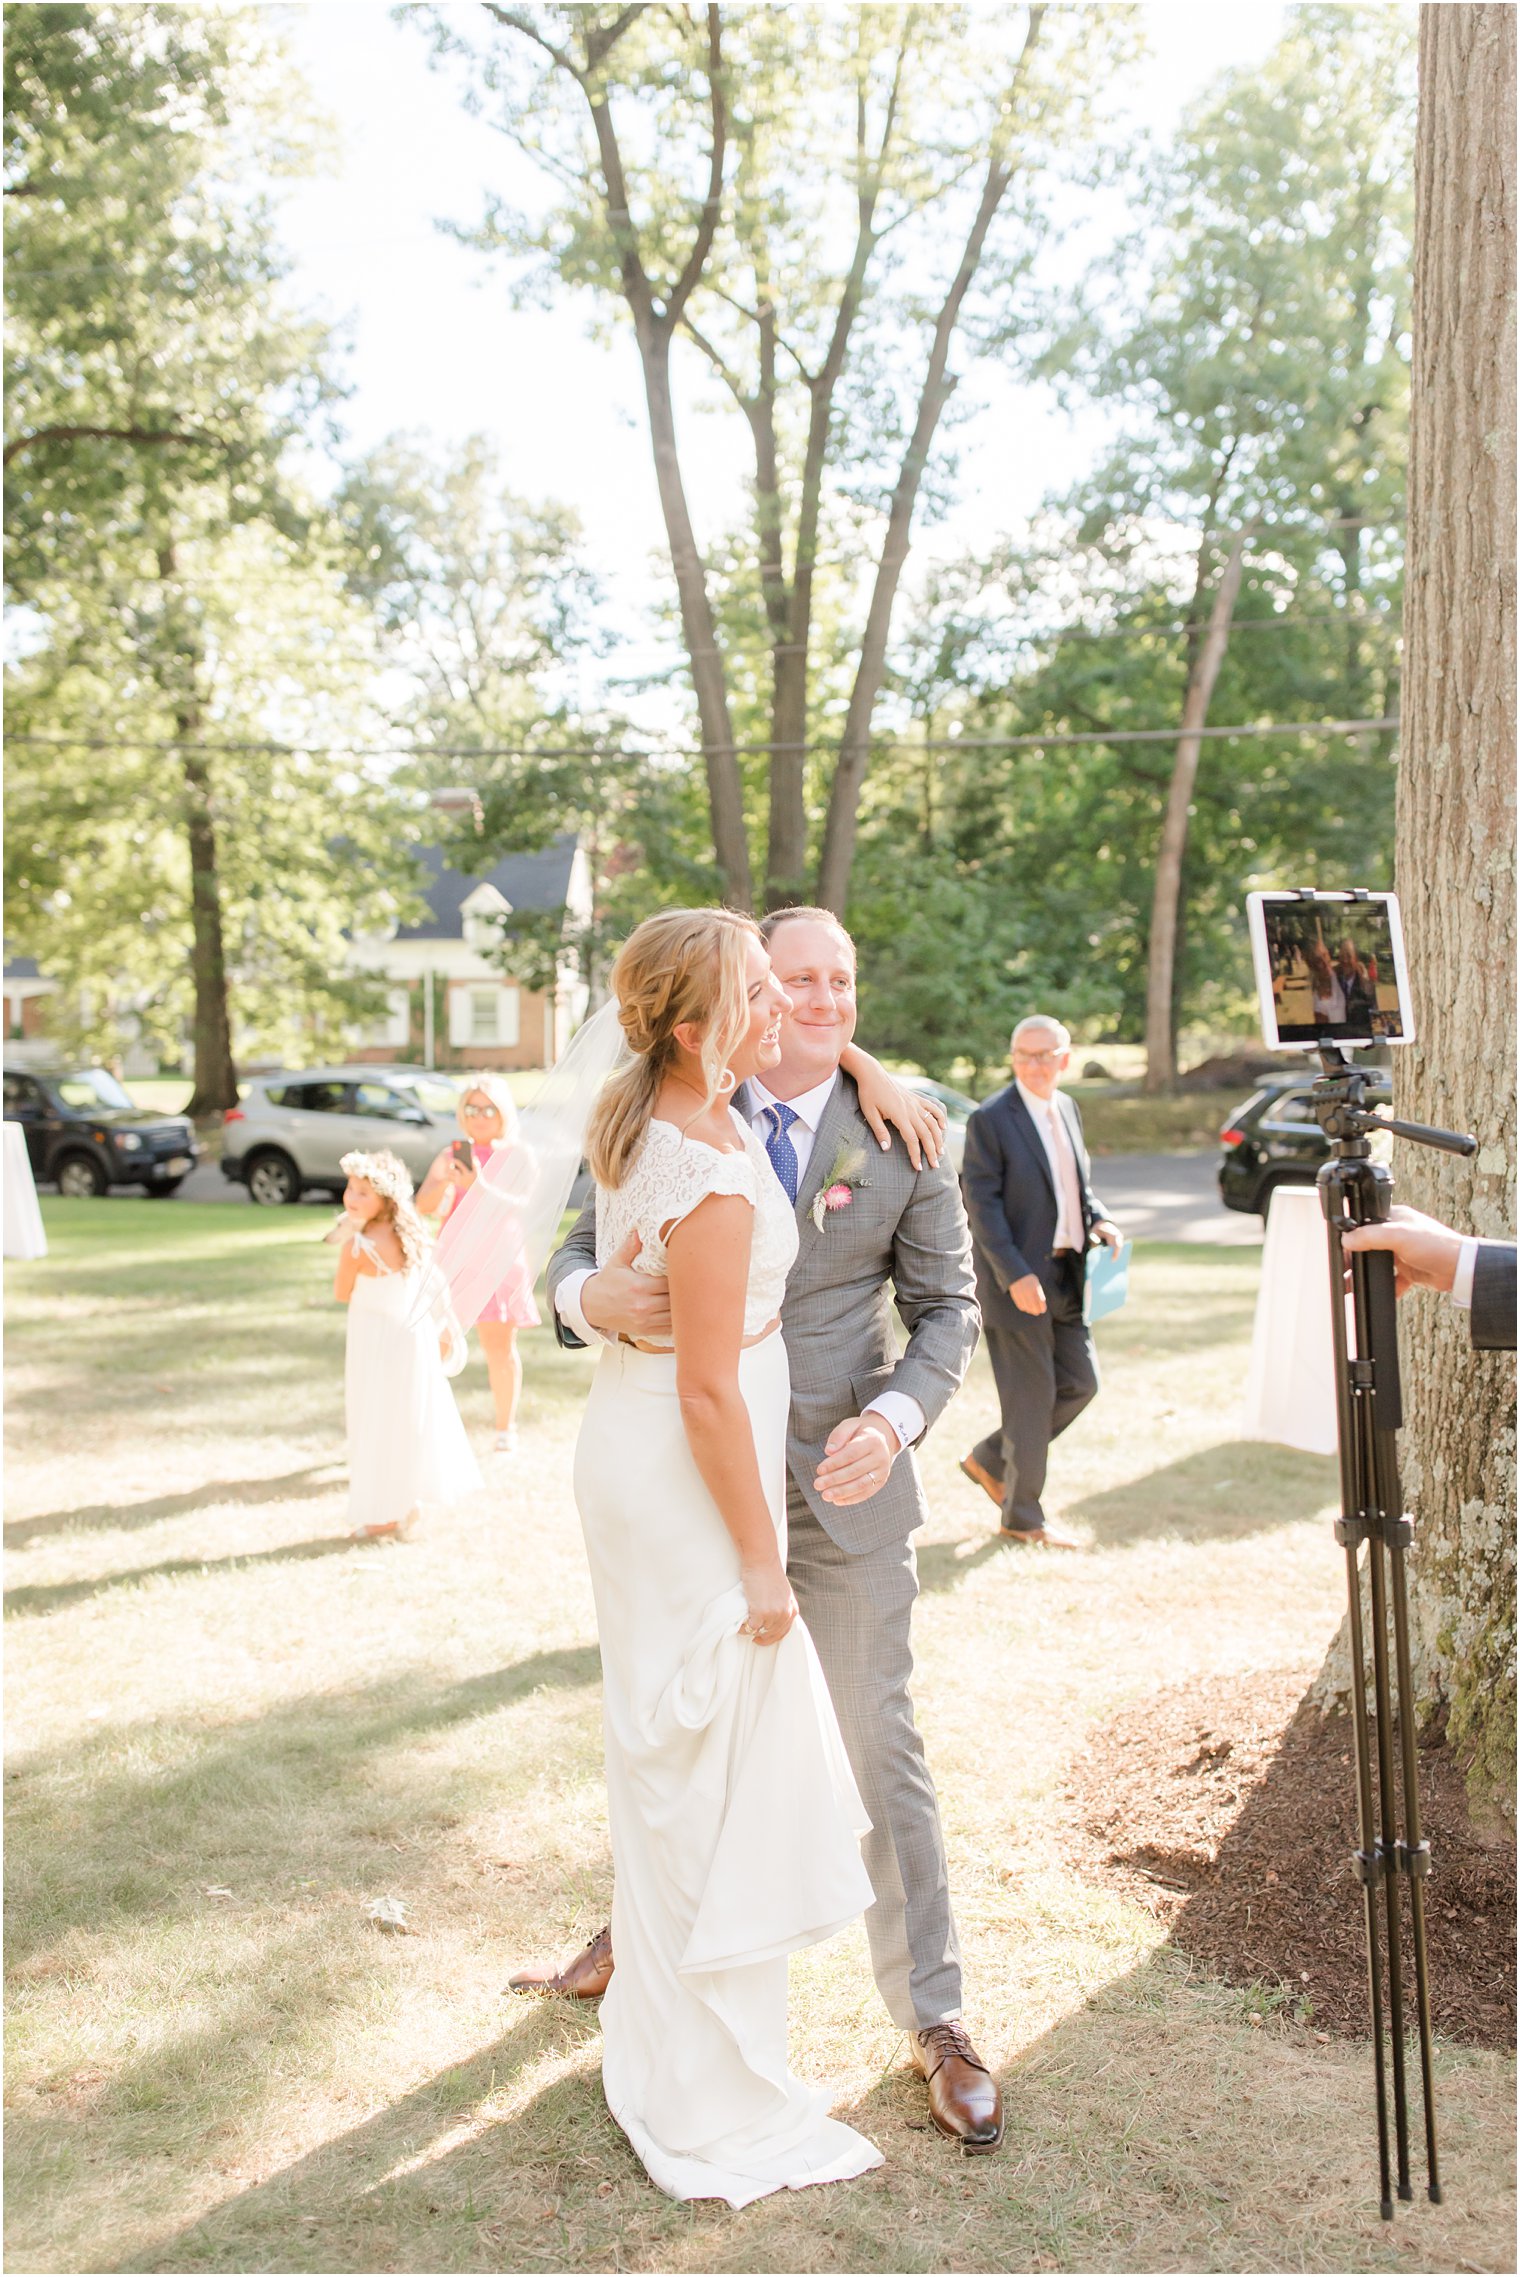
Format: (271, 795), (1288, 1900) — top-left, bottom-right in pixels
(7, 1644), (601, 1963)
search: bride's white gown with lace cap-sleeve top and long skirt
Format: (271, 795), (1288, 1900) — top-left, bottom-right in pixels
(576, 1116), (881, 2206)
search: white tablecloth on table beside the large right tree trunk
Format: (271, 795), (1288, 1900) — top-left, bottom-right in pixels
(1245, 1186), (1336, 1455)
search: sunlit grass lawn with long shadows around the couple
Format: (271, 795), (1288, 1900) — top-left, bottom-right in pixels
(7, 1200), (1515, 2270)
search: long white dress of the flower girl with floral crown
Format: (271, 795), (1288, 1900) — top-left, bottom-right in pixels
(344, 1234), (482, 1528)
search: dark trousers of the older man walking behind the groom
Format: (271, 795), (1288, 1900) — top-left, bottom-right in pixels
(973, 1259), (1097, 1530)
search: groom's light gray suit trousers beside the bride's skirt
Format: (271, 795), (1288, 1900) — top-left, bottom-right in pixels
(787, 1480), (960, 2031)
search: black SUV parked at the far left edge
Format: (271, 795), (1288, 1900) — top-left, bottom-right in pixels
(5, 1068), (200, 1195)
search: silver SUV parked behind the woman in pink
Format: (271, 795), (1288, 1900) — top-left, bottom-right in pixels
(221, 1068), (464, 1209)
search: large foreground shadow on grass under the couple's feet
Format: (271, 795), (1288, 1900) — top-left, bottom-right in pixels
(118, 1956), (1410, 2272)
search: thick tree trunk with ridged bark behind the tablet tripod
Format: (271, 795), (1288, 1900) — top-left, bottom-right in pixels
(1315, 5), (1515, 1822)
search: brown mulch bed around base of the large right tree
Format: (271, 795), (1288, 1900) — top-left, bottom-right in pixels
(1067, 1669), (1515, 2047)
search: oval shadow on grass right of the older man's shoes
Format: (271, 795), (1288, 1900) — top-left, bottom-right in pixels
(1069, 1439), (1336, 1548)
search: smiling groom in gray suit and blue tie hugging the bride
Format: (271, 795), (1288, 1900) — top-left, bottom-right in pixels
(523, 909), (1003, 2152)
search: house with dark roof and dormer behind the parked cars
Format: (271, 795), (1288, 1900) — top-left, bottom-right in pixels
(353, 828), (592, 1068)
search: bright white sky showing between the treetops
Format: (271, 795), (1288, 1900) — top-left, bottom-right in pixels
(271, 0), (1288, 663)
